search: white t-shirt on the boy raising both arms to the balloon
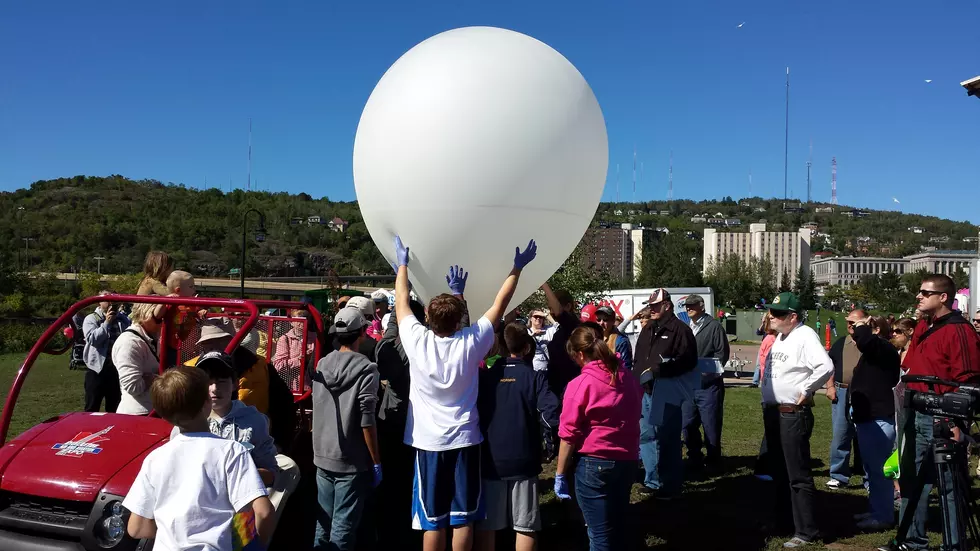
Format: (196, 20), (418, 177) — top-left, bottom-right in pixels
(398, 316), (494, 451)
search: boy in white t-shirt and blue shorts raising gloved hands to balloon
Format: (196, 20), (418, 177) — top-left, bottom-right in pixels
(395, 236), (537, 551)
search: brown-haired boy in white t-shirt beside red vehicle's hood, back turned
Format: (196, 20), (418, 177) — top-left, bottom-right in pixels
(123, 367), (274, 550)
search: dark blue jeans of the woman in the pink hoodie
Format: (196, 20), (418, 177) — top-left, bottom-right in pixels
(575, 456), (636, 551)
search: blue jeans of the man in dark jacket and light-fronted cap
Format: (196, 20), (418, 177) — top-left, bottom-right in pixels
(640, 394), (684, 496)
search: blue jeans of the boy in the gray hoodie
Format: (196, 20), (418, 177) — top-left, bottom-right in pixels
(313, 468), (371, 551)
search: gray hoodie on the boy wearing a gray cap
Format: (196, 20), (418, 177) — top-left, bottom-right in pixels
(313, 350), (379, 473)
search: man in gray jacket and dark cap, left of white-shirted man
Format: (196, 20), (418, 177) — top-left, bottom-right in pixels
(683, 295), (730, 469)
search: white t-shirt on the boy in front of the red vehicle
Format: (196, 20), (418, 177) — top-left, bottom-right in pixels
(123, 432), (267, 551)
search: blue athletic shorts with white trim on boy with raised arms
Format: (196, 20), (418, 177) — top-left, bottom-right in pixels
(412, 446), (486, 530)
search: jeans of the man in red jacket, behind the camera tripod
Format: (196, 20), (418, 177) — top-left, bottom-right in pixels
(898, 410), (963, 549)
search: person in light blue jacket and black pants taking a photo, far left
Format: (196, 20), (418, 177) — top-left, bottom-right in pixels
(82, 291), (130, 413)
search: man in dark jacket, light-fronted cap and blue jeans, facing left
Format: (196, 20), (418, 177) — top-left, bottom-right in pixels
(633, 289), (701, 499)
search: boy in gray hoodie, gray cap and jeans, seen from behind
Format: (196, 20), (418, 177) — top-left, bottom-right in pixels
(313, 308), (382, 551)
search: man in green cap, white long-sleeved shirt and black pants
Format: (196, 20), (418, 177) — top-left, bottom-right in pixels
(761, 293), (834, 549)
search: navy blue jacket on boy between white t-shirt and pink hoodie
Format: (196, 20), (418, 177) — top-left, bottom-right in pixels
(477, 358), (558, 480)
